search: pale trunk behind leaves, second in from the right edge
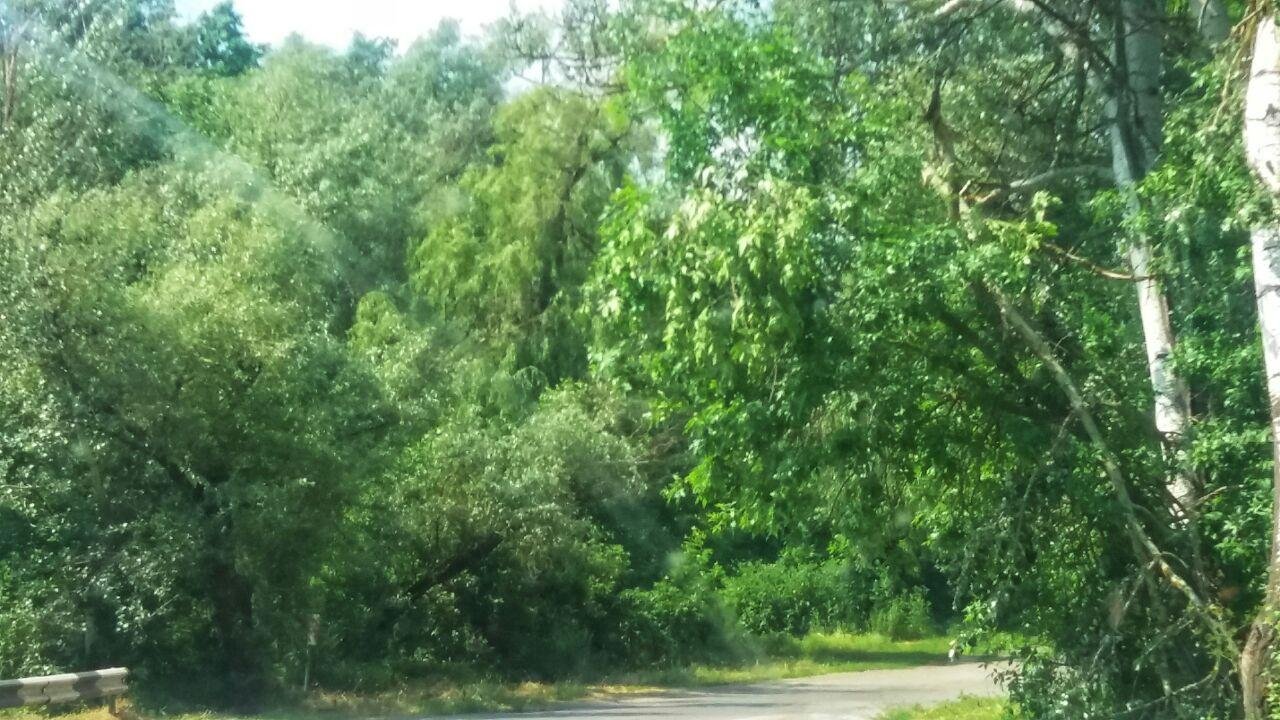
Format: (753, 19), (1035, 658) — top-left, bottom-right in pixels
(1107, 0), (1196, 514)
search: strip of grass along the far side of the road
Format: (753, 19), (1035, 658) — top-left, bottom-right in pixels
(0, 633), (967, 720)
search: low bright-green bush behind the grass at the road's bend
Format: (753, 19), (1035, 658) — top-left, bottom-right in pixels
(721, 561), (869, 635)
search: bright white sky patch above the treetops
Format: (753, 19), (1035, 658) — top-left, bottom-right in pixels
(177, 0), (563, 49)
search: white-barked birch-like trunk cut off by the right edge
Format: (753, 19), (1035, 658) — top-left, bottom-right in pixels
(1240, 15), (1280, 720)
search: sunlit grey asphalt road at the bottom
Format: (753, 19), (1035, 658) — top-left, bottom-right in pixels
(440, 662), (1000, 720)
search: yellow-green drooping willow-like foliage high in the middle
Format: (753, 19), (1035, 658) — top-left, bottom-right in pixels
(411, 88), (631, 383)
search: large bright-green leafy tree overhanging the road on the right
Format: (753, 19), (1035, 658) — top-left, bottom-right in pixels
(593, 3), (1260, 716)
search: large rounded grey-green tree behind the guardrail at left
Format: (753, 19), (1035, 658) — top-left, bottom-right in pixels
(0, 162), (379, 691)
